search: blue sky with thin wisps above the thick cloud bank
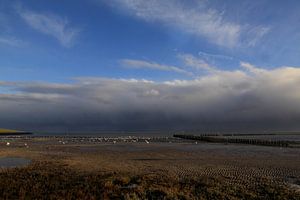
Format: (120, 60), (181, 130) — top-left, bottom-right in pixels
(0, 0), (300, 82)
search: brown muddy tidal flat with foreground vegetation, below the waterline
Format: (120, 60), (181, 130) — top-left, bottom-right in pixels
(0, 136), (300, 199)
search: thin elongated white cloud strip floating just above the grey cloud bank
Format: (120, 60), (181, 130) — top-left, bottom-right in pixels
(121, 59), (193, 76)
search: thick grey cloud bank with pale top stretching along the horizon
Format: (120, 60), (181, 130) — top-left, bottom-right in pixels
(0, 63), (300, 131)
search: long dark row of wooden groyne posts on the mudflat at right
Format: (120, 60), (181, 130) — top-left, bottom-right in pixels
(173, 134), (290, 147)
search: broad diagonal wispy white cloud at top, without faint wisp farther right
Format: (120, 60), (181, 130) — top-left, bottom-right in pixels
(107, 0), (242, 47)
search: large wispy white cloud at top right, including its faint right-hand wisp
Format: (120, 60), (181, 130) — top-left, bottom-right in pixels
(104, 0), (270, 48)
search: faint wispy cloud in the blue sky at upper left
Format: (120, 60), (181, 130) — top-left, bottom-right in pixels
(17, 7), (80, 47)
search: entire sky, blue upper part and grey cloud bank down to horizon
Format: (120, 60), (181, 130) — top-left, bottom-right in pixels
(0, 0), (300, 131)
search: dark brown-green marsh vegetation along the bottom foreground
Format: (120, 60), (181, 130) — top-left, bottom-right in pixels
(0, 162), (300, 199)
